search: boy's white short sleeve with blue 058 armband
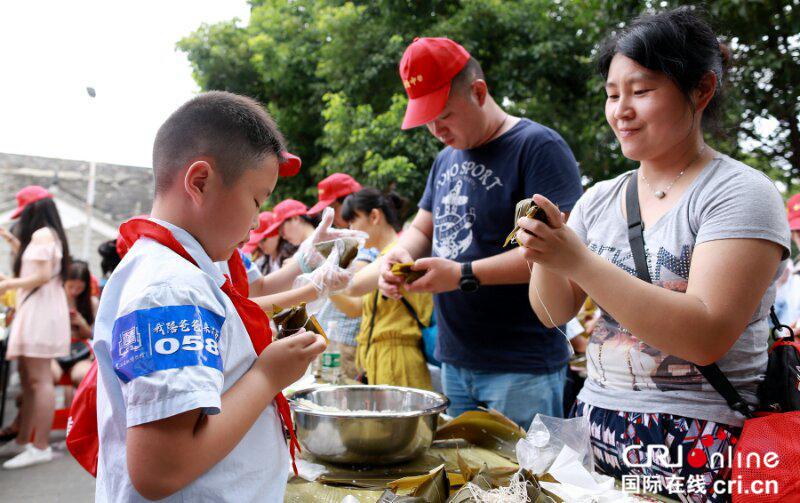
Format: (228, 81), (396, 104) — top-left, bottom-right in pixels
(111, 284), (225, 427)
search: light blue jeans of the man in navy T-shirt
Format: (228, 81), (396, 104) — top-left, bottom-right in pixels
(442, 363), (567, 430)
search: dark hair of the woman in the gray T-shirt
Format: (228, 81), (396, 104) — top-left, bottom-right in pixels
(597, 6), (731, 129)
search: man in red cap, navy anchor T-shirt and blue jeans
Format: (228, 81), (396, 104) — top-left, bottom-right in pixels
(380, 38), (582, 427)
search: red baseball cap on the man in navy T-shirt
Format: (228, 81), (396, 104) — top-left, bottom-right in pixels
(400, 37), (470, 129)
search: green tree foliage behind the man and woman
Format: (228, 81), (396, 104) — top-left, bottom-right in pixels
(178, 0), (800, 206)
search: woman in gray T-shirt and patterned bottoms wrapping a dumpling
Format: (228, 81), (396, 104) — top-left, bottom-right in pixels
(517, 8), (790, 501)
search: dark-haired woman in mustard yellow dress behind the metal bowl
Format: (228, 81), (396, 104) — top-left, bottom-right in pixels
(331, 187), (433, 389)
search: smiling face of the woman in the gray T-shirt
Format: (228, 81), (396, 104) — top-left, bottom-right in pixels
(605, 54), (701, 161)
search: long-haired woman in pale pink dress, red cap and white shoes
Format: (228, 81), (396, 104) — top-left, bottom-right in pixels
(0, 185), (70, 469)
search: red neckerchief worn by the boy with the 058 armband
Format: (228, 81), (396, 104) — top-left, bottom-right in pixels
(119, 218), (300, 475)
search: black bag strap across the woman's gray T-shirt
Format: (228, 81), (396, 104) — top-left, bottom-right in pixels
(625, 171), (753, 418)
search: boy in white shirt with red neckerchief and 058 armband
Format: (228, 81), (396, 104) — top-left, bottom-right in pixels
(94, 92), (325, 502)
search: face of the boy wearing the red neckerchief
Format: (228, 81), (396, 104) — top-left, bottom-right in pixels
(201, 155), (278, 261)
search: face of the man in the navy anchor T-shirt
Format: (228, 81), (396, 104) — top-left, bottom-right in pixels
(425, 84), (484, 150)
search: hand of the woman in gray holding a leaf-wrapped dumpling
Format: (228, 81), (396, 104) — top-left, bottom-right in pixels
(516, 194), (591, 277)
